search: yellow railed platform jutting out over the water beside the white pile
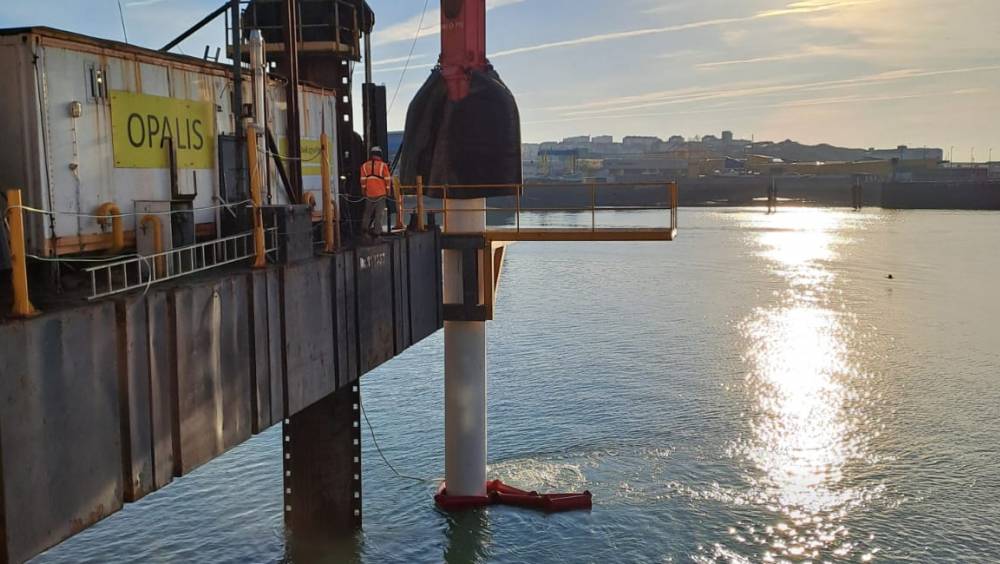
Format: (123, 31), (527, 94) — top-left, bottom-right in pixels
(396, 178), (678, 241)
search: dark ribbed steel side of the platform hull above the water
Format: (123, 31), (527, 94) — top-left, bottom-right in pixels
(0, 231), (442, 562)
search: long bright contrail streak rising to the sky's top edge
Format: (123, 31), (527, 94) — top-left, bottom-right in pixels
(491, 0), (879, 57)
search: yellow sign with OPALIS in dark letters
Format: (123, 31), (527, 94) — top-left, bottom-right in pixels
(111, 90), (215, 169)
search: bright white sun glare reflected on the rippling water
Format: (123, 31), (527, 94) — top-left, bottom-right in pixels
(715, 209), (873, 561)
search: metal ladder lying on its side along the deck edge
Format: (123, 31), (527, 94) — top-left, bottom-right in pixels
(84, 227), (278, 300)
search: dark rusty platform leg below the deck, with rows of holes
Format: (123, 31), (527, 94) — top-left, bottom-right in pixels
(282, 382), (361, 551)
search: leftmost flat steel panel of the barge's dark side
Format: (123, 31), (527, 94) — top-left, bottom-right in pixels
(0, 303), (122, 562)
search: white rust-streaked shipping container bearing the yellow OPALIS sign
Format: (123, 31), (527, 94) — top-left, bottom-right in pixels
(0, 28), (339, 255)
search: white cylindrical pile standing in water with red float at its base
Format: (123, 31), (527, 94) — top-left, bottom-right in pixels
(442, 198), (486, 496)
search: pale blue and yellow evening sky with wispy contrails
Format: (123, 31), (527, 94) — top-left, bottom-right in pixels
(0, 0), (1000, 156)
